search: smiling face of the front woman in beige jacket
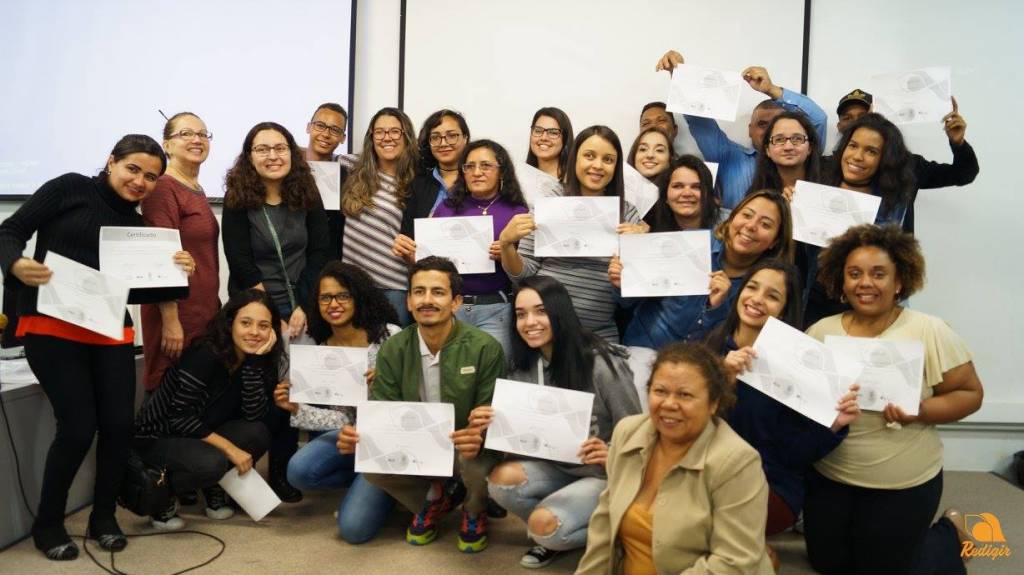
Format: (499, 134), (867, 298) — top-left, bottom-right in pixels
(647, 362), (718, 445)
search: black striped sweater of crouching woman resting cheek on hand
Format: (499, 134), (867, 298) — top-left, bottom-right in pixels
(135, 344), (274, 439)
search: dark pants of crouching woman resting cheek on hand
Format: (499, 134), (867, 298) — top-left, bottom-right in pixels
(138, 419), (270, 493)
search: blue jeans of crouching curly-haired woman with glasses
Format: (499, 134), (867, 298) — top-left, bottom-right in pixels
(288, 431), (394, 544)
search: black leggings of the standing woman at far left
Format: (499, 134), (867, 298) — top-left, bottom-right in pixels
(25, 334), (135, 532)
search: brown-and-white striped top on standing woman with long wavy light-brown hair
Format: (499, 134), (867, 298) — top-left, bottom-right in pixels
(338, 156), (409, 290)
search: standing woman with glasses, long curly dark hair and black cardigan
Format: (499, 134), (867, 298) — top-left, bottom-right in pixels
(221, 122), (330, 502)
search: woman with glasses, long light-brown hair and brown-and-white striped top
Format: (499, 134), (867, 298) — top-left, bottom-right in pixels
(340, 107), (420, 325)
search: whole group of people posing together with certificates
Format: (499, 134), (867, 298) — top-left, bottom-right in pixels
(0, 47), (982, 573)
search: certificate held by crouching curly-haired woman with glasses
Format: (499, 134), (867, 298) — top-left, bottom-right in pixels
(288, 345), (367, 405)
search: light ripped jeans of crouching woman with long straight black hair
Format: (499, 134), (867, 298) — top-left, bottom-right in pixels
(487, 459), (608, 551)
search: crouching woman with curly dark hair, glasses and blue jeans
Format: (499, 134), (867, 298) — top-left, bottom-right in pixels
(273, 261), (399, 543)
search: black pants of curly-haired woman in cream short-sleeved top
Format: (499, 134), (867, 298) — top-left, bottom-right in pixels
(804, 469), (964, 575)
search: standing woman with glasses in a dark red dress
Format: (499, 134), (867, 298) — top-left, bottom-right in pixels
(140, 112), (220, 392)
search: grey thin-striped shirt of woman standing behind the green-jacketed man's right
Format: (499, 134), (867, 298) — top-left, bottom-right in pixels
(509, 202), (640, 344)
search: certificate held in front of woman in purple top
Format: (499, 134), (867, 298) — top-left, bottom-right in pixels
(414, 216), (495, 273)
